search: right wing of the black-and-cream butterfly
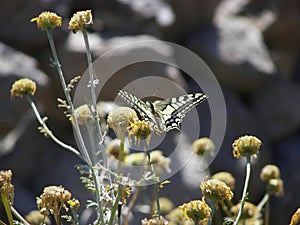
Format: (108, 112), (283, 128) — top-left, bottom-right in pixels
(153, 93), (207, 132)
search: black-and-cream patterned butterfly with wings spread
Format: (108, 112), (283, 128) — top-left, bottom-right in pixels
(118, 90), (208, 133)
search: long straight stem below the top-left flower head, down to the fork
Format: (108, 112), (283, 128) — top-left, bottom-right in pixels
(47, 29), (91, 165)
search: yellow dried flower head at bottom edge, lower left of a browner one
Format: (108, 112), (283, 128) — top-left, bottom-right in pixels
(179, 199), (211, 223)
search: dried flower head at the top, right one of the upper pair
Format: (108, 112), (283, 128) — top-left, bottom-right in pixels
(69, 10), (93, 33)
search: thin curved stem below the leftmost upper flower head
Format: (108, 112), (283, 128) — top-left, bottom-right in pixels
(26, 95), (81, 157)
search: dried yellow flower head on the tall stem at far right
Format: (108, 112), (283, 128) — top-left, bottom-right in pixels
(232, 135), (262, 158)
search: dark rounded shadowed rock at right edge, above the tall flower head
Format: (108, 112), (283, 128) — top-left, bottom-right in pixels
(253, 79), (300, 140)
